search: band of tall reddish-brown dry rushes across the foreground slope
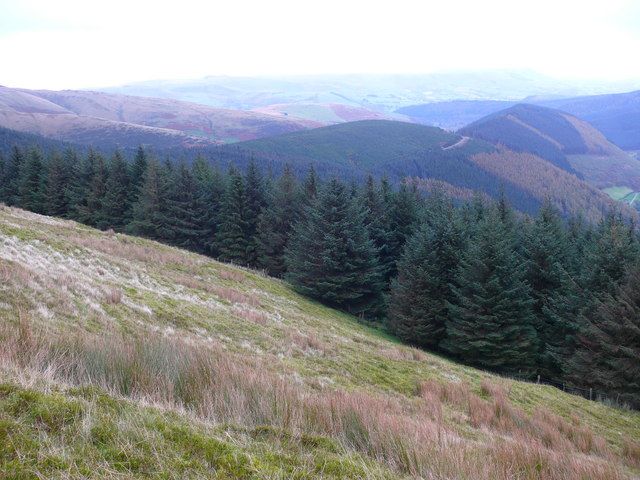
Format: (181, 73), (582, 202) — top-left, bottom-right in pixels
(0, 314), (637, 480)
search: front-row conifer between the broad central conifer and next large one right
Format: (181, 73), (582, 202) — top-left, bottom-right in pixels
(389, 192), (465, 348)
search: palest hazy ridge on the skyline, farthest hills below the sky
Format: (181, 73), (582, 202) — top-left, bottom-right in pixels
(103, 70), (640, 112)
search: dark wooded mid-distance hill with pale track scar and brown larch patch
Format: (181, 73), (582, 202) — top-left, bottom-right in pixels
(215, 120), (624, 220)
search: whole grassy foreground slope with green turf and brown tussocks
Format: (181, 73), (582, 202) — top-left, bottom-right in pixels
(0, 204), (640, 480)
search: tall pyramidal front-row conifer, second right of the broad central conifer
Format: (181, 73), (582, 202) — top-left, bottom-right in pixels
(442, 209), (538, 373)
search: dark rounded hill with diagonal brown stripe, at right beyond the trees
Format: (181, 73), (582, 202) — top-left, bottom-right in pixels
(458, 104), (640, 190)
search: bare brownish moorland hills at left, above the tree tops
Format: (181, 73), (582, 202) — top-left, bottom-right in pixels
(0, 87), (312, 149)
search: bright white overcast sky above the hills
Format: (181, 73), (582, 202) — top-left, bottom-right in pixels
(0, 0), (640, 89)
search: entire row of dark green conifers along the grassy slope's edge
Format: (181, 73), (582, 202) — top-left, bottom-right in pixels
(0, 147), (640, 407)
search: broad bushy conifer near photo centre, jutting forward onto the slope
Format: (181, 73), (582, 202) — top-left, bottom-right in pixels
(285, 179), (382, 315)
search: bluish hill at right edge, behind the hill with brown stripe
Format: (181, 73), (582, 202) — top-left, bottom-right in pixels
(540, 90), (640, 150)
